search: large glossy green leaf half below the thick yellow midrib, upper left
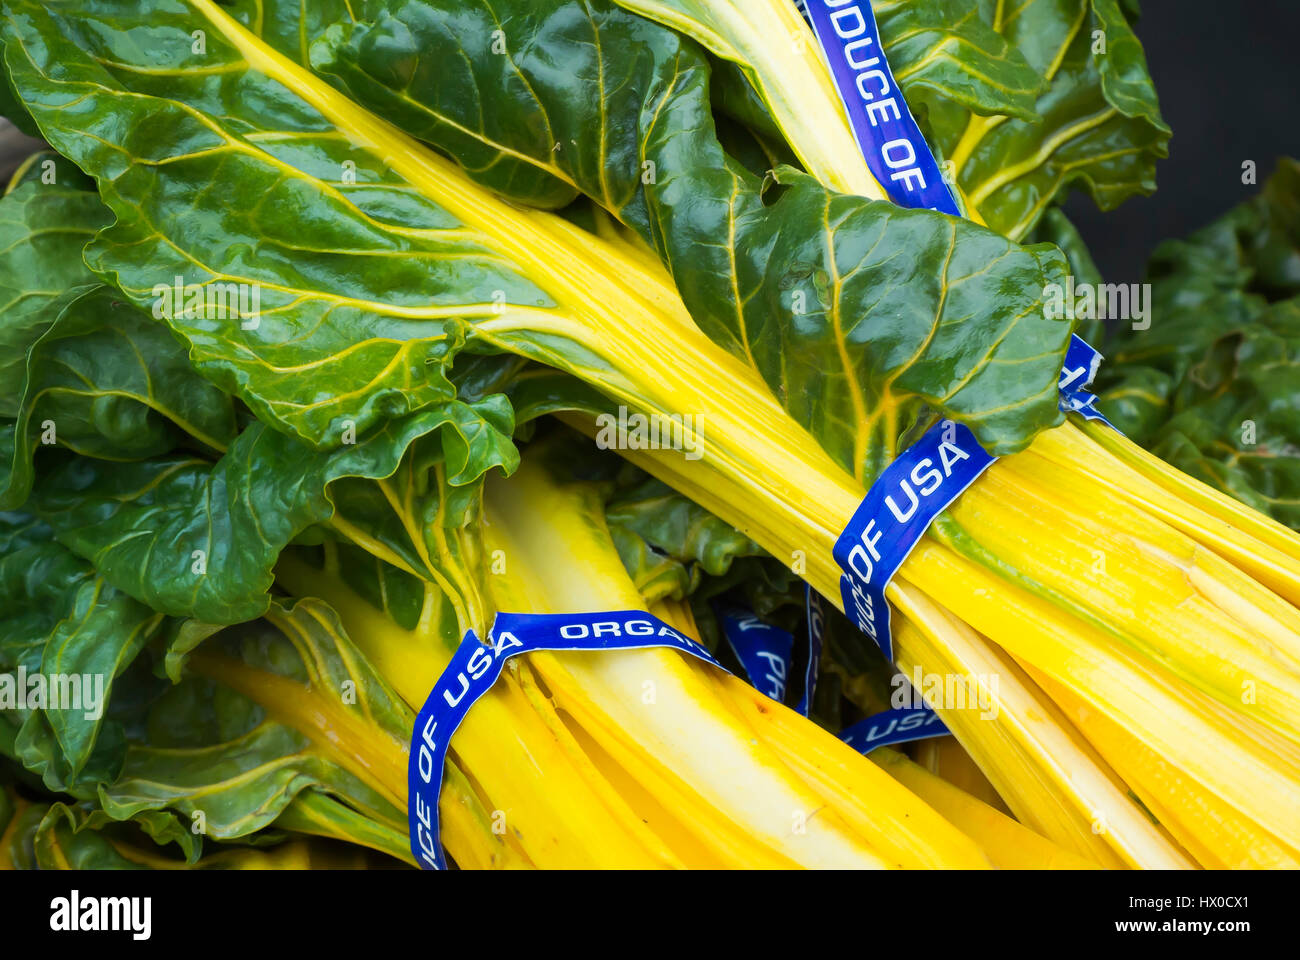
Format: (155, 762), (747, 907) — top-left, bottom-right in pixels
(5, 0), (550, 446)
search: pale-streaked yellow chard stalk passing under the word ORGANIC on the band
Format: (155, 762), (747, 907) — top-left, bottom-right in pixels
(484, 460), (984, 866)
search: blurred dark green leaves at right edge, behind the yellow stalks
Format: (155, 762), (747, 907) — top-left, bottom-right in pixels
(1099, 157), (1300, 529)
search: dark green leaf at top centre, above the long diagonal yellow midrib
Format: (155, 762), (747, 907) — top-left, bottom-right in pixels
(312, 0), (691, 237)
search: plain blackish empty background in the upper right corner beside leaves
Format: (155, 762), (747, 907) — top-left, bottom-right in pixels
(1065, 0), (1300, 284)
